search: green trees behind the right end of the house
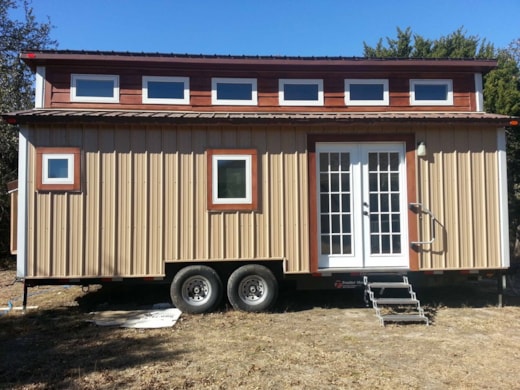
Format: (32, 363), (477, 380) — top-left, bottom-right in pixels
(363, 27), (520, 253)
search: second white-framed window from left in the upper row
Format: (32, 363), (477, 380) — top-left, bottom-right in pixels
(143, 76), (190, 104)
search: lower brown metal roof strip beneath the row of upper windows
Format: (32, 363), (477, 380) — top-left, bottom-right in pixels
(2, 109), (512, 126)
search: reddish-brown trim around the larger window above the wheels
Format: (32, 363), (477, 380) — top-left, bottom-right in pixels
(206, 149), (258, 211)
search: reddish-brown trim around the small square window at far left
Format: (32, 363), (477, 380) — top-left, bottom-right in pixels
(36, 147), (81, 192)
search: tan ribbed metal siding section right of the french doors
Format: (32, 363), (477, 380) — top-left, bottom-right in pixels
(417, 126), (502, 270)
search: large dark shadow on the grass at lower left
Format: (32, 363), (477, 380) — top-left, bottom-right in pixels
(0, 284), (186, 388)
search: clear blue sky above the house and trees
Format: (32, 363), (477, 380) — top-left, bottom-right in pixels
(26, 0), (520, 56)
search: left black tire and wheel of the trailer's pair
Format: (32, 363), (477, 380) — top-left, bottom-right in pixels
(170, 265), (223, 314)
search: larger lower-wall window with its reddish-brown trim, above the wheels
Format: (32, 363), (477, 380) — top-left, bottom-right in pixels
(207, 149), (258, 211)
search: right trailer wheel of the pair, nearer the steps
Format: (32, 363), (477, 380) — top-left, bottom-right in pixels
(227, 264), (278, 312)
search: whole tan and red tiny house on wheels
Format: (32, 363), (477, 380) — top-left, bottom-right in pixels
(3, 51), (509, 313)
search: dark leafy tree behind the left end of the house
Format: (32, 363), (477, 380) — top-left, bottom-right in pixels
(0, 0), (56, 255)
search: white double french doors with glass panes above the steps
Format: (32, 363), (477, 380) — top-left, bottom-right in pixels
(316, 143), (409, 269)
